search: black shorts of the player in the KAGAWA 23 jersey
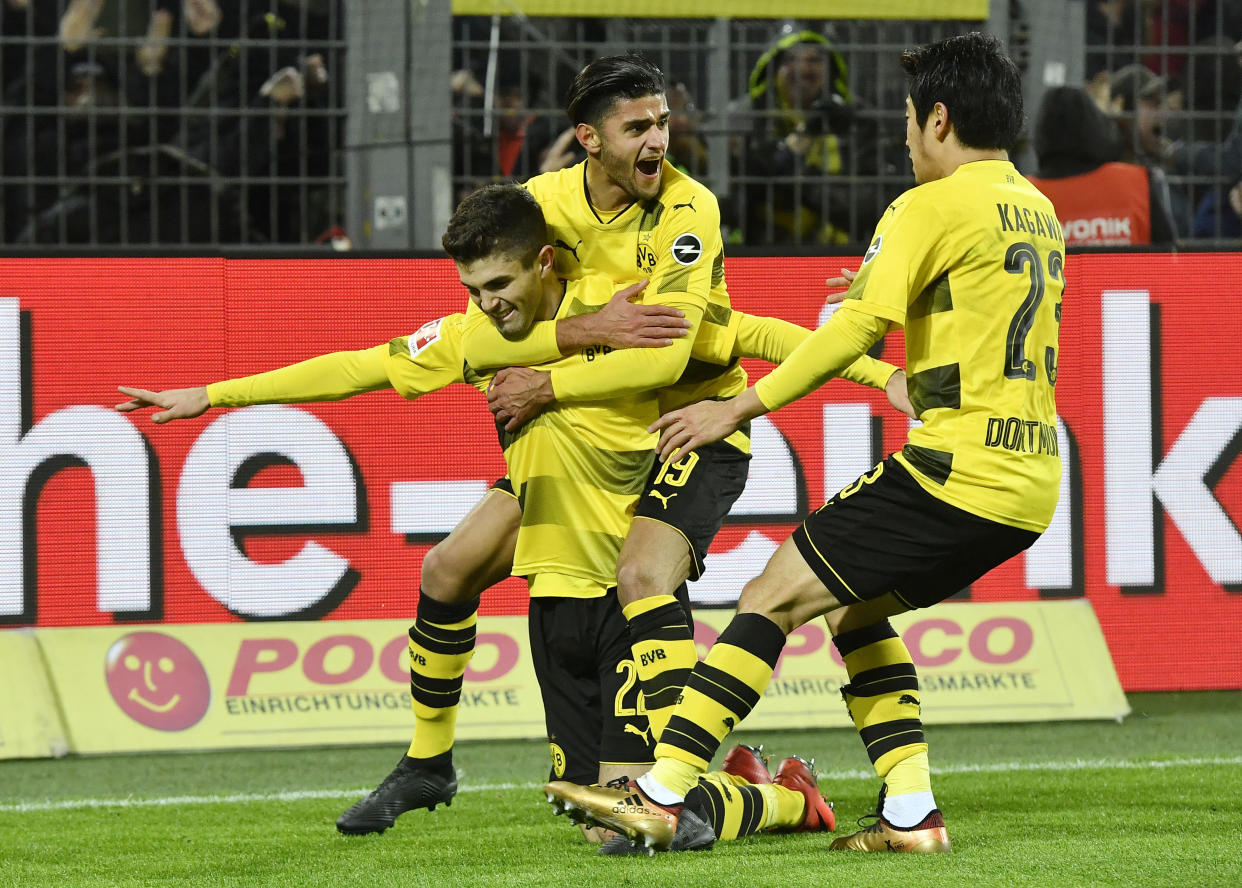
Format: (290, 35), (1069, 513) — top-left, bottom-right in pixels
(792, 457), (1040, 607)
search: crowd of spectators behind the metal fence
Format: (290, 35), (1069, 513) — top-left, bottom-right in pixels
(0, 0), (1242, 247)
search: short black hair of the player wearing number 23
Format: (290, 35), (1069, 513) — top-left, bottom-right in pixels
(902, 31), (1022, 150)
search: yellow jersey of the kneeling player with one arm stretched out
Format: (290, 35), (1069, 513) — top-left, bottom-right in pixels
(207, 304), (660, 597)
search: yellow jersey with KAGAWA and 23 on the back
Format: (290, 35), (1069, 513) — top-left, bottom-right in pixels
(846, 160), (1066, 532)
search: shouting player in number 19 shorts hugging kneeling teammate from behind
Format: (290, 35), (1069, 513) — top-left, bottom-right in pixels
(310, 56), (905, 832)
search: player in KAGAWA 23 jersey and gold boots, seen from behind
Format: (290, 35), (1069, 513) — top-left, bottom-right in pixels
(548, 34), (1064, 852)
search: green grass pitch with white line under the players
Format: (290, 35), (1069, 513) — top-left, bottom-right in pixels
(0, 692), (1242, 888)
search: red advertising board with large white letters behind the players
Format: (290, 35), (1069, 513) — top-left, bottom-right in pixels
(0, 253), (1242, 691)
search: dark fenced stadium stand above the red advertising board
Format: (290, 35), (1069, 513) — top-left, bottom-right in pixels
(0, 0), (1242, 253)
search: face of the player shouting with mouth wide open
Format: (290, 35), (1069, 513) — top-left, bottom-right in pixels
(599, 94), (668, 200)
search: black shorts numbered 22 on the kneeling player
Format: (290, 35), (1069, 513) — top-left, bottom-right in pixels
(528, 592), (656, 784)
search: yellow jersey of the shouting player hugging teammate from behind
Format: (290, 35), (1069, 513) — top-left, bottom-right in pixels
(516, 161), (746, 417)
